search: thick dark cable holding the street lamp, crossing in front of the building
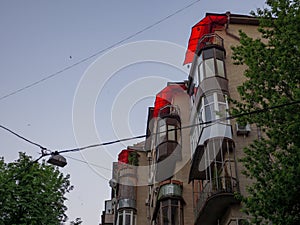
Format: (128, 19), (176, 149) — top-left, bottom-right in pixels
(0, 100), (300, 156)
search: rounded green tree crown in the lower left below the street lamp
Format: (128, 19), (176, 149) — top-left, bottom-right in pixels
(0, 153), (72, 225)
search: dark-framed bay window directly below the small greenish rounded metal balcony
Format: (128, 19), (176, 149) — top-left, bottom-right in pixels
(156, 199), (183, 225)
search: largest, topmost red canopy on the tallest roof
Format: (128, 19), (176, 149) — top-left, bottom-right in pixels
(183, 15), (227, 64)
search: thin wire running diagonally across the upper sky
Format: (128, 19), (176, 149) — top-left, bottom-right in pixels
(0, 0), (201, 101)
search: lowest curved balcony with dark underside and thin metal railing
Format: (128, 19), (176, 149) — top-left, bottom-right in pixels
(194, 176), (238, 225)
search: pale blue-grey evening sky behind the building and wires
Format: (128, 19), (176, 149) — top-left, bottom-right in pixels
(0, 0), (264, 225)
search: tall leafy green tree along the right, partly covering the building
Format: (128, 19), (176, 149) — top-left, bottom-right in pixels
(233, 0), (300, 225)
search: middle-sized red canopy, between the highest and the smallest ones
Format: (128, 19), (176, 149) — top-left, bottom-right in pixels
(153, 84), (186, 117)
